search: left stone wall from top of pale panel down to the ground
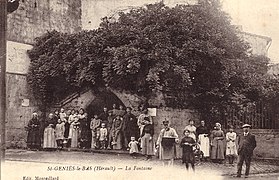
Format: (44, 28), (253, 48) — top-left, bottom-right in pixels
(6, 41), (37, 147)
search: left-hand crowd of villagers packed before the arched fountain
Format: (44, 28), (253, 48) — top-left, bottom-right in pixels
(26, 104), (152, 152)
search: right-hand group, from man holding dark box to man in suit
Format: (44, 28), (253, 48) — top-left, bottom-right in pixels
(157, 120), (256, 177)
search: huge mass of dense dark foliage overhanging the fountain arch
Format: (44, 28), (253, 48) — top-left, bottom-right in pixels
(28, 0), (278, 124)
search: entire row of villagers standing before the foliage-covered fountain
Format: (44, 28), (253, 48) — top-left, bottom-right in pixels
(26, 104), (256, 176)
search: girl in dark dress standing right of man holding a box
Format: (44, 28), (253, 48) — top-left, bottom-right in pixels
(180, 129), (196, 171)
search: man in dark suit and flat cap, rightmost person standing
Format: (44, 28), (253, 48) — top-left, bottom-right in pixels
(237, 124), (257, 178)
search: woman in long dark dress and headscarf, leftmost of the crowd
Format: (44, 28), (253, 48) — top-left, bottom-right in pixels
(26, 113), (41, 149)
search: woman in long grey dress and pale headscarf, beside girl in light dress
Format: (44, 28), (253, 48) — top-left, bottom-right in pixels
(211, 123), (225, 163)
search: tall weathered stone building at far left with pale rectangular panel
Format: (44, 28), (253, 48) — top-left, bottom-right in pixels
(6, 0), (81, 147)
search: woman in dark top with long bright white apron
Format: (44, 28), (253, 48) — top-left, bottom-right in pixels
(197, 121), (210, 160)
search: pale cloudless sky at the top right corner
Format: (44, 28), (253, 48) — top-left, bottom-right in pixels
(221, 0), (279, 63)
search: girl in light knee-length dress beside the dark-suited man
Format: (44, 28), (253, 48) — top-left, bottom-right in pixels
(226, 126), (237, 164)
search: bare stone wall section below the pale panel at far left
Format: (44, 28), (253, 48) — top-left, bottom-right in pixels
(6, 73), (38, 147)
